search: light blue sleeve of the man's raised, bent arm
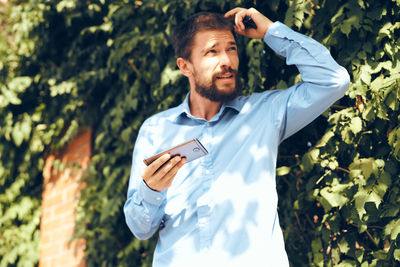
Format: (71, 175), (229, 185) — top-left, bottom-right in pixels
(264, 22), (350, 141)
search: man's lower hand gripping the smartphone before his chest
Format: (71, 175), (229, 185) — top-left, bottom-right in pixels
(142, 154), (186, 191)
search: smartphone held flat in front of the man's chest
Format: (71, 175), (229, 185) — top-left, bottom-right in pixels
(143, 138), (208, 166)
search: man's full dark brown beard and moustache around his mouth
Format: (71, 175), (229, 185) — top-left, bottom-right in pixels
(195, 68), (242, 103)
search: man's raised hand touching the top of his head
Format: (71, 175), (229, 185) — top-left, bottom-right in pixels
(224, 7), (273, 39)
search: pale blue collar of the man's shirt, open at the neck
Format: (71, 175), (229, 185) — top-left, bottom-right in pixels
(175, 92), (244, 122)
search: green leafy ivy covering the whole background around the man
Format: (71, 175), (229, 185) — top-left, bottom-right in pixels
(0, 0), (400, 266)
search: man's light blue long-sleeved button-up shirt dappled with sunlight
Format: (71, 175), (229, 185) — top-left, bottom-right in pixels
(124, 22), (349, 267)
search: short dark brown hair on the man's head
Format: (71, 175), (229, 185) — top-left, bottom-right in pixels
(172, 12), (236, 60)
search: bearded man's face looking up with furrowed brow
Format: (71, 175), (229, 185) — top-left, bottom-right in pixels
(190, 30), (241, 102)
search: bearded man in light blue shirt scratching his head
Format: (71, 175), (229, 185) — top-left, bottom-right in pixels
(124, 8), (349, 267)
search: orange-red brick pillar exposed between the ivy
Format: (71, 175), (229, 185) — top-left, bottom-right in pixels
(39, 130), (91, 267)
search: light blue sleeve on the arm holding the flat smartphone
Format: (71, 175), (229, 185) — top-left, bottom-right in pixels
(124, 123), (165, 242)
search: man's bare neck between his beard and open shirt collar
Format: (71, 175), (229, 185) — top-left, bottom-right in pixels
(189, 89), (222, 121)
